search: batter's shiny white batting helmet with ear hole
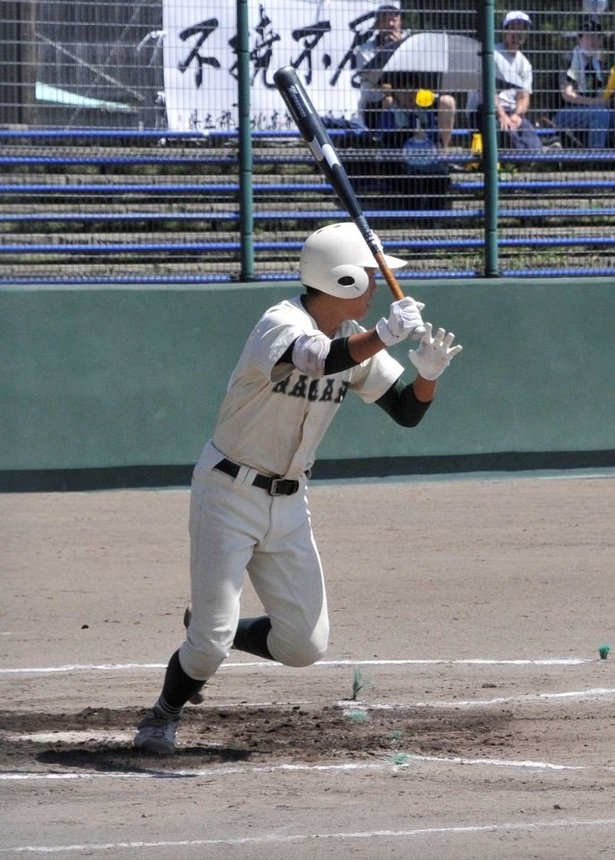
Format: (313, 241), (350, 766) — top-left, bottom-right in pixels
(299, 222), (407, 299)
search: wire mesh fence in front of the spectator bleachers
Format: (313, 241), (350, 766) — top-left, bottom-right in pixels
(0, 0), (615, 282)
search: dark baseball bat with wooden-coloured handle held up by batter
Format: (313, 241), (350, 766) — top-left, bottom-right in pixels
(273, 66), (404, 299)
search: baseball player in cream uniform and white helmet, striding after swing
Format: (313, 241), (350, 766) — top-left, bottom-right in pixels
(134, 223), (461, 755)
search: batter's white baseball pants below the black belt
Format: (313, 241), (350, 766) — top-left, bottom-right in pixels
(179, 442), (329, 680)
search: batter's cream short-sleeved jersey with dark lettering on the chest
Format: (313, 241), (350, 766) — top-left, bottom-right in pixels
(213, 296), (403, 478)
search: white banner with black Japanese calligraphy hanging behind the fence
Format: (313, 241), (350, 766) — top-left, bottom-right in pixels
(163, 0), (380, 131)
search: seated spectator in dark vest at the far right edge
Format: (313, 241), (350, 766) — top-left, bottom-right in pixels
(553, 19), (611, 149)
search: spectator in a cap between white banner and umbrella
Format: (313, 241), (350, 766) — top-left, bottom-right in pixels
(355, 3), (409, 131)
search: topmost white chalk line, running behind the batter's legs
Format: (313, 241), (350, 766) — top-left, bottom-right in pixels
(0, 657), (598, 675)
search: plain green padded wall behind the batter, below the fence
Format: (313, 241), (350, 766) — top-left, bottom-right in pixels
(0, 278), (615, 491)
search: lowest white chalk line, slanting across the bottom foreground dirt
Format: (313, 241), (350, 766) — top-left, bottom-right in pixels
(0, 818), (615, 854)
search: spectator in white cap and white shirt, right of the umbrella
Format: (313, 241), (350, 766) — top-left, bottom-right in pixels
(467, 11), (542, 149)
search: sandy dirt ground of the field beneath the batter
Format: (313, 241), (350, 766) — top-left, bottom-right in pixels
(0, 474), (615, 860)
